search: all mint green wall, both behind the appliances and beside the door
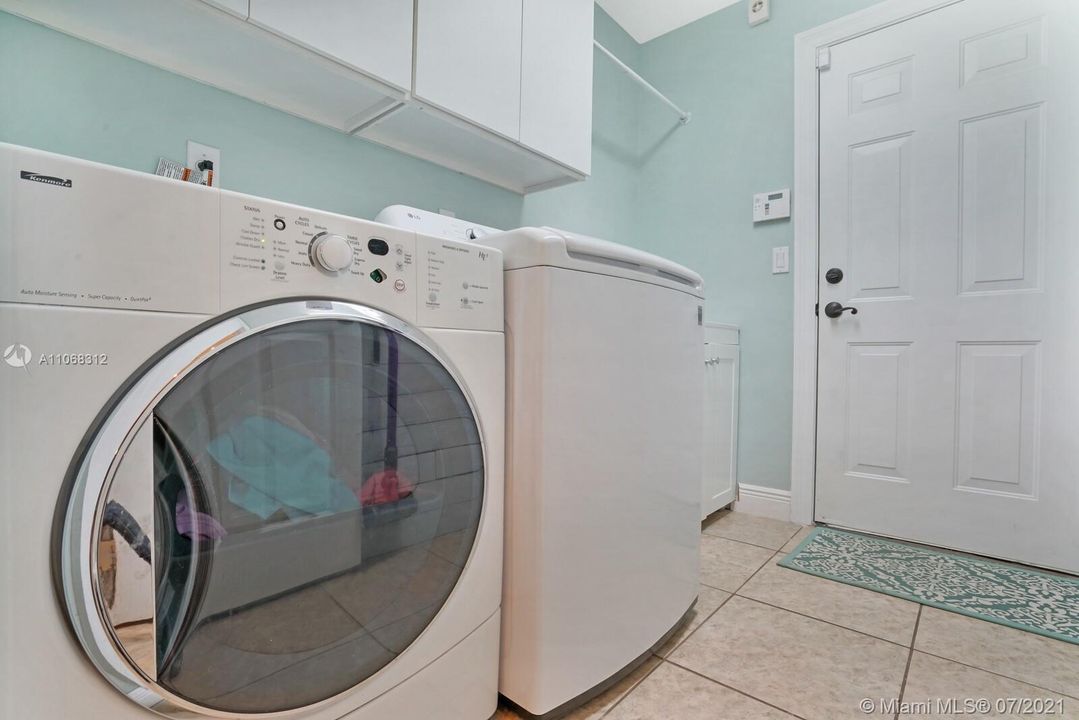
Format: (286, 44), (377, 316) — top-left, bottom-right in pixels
(0, 0), (875, 496)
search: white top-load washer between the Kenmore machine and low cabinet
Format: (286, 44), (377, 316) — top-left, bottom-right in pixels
(380, 207), (704, 716)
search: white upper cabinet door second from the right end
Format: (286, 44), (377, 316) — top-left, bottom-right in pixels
(412, 0), (521, 140)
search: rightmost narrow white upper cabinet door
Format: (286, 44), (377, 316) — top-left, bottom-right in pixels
(521, 0), (595, 175)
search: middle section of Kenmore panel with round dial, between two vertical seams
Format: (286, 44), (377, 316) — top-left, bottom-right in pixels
(221, 191), (418, 321)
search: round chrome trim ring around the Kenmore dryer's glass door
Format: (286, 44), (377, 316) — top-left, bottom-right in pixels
(58, 300), (487, 718)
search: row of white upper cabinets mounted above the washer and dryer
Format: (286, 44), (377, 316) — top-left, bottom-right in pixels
(0, 0), (593, 193)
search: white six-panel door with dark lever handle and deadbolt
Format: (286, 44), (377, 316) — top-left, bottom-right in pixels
(816, 0), (1079, 571)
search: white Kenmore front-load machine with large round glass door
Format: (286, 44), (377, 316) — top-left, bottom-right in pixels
(0, 145), (505, 720)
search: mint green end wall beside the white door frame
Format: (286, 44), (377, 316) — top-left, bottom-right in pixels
(633, 0), (875, 489)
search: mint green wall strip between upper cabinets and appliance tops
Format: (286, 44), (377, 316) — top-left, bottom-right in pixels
(0, 13), (522, 228)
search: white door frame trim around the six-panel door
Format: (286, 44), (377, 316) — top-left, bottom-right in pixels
(791, 0), (964, 525)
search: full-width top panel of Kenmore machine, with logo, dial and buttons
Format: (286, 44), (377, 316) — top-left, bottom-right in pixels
(0, 144), (504, 331)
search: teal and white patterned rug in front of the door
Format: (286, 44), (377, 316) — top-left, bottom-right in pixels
(779, 528), (1079, 644)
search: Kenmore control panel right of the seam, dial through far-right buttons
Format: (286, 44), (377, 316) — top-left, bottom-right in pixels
(221, 192), (504, 331)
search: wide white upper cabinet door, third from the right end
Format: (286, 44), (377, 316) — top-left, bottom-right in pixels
(245, 0), (412, 91)
